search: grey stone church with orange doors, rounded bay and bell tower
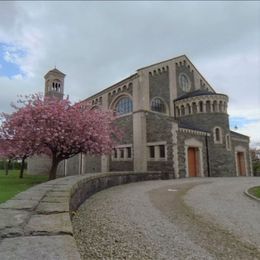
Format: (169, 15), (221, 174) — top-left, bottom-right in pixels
(29, 55), (252, 178)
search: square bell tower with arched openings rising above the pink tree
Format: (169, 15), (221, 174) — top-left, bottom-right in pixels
(44, 68), (66, 99)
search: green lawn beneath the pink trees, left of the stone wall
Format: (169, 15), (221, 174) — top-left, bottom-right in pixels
(0, 170), (48, 203)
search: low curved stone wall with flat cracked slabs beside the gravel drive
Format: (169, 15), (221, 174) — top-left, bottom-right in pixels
(0, 172), (173, 260)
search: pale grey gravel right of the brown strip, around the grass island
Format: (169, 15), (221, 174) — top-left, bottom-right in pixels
(184, 178), (260, 250)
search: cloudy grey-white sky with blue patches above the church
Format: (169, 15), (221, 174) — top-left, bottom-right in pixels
(0, 1), (260, 147)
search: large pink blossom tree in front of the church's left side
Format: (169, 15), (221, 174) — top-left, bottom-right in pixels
(0, 94), (119, 180)
